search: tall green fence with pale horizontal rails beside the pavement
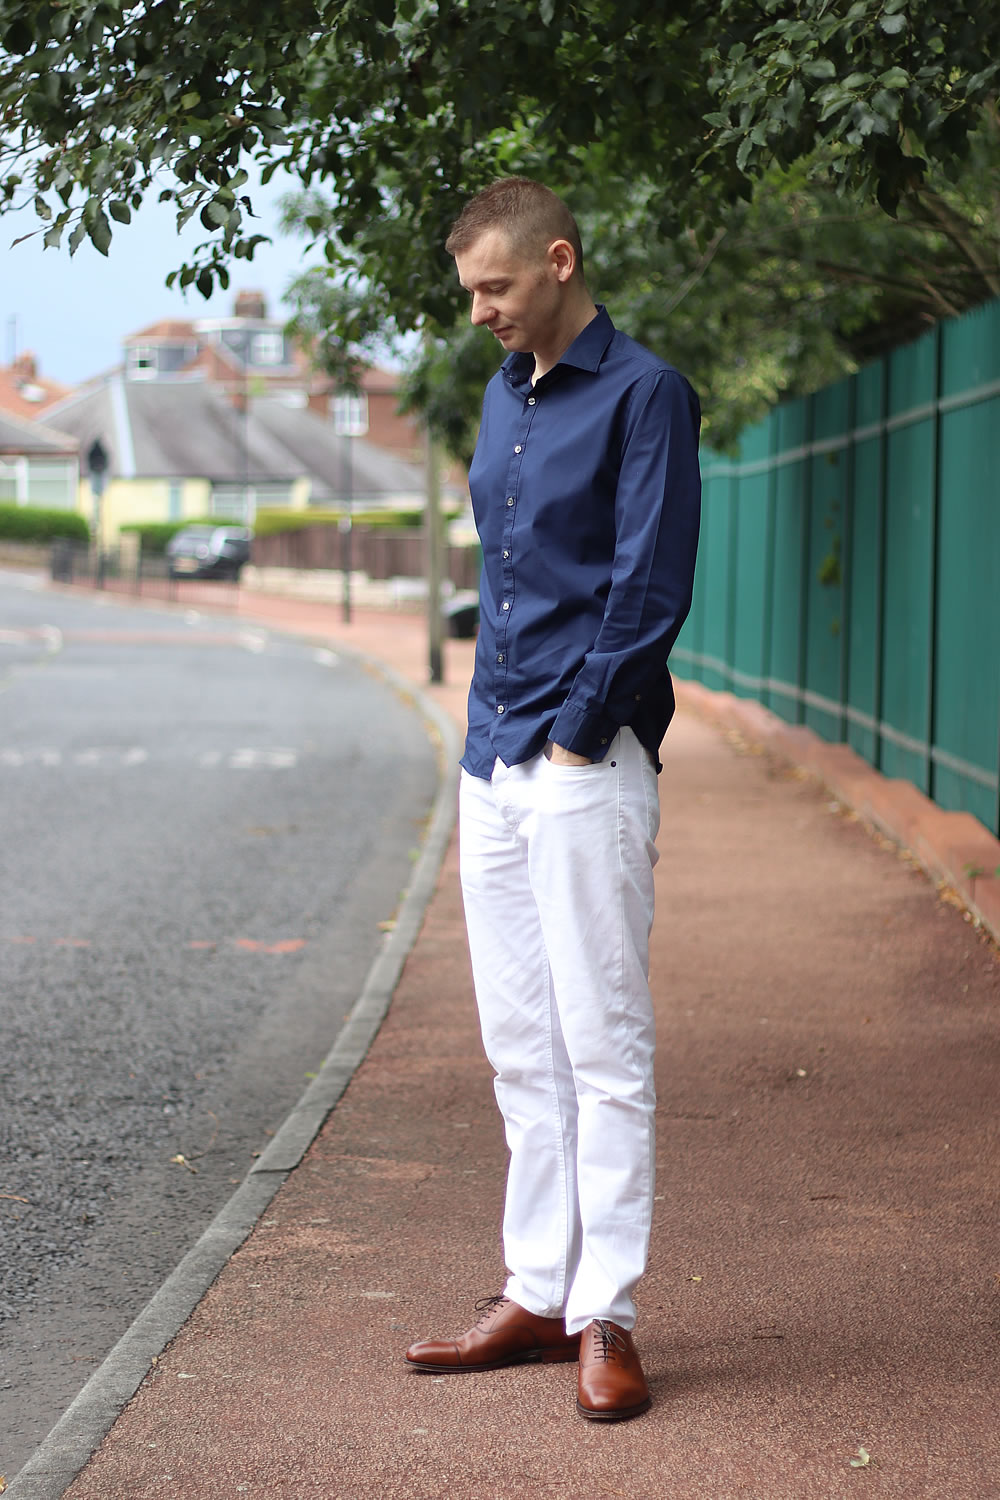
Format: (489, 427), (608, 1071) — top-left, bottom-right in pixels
(673, 300), (1000, 833)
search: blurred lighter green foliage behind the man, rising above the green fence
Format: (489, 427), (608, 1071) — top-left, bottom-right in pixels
(286, 120), (1000, 450)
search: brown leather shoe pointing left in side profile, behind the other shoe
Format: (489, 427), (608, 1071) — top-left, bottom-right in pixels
(406, 1298), (580, 1376)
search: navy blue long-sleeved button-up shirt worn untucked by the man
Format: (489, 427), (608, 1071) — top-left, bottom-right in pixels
(462, 308), (700, 777)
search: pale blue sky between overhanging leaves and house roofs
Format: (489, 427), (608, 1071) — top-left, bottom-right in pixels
(0, 174), (321, 386)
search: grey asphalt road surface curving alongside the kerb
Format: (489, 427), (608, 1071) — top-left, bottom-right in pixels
(0, 573), (436, 1478)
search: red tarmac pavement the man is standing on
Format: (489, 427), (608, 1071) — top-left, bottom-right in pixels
(48, 596), (1000, 1500)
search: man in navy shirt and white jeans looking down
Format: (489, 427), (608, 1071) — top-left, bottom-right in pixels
(406, 177), (700, 1421)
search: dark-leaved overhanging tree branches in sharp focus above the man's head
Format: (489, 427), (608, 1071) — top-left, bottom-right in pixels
(0, 0), (1000, 444)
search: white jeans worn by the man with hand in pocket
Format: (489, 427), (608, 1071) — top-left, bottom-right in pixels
(460, 729), (660, 1334)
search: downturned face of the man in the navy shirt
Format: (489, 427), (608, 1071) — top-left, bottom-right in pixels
(454, 230), (562, 354)
